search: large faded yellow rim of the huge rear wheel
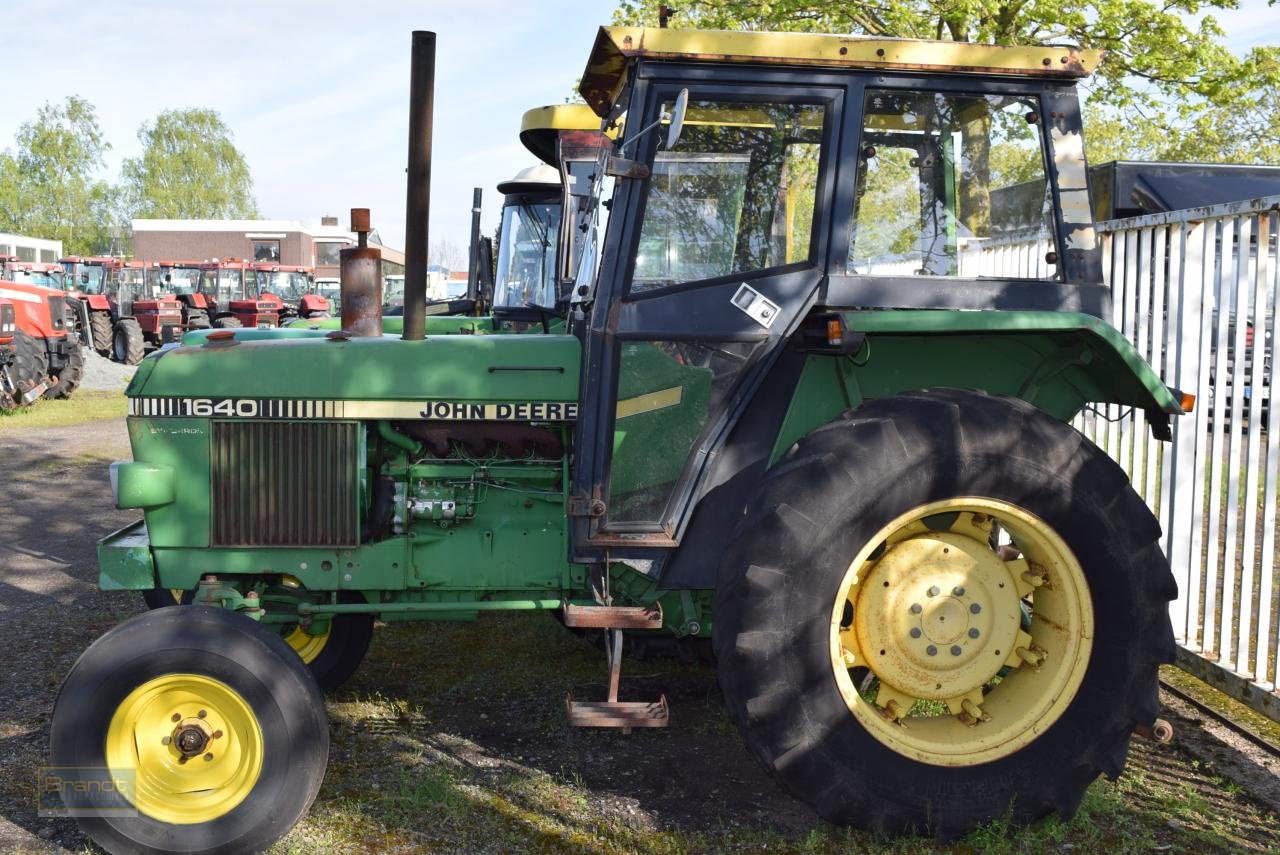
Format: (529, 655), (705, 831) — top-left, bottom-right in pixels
(831, 498), (1093, 767)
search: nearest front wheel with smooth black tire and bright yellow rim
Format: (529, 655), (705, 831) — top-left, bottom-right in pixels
(50, 607), (329, 852)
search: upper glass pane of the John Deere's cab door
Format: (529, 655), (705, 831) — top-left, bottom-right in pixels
(631, 101), (824, 292)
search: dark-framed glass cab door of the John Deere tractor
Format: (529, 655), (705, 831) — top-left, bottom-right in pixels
(570, 73), (845, 570)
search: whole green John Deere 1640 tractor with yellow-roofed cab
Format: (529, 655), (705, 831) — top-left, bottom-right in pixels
(51, 27), (1183, 851)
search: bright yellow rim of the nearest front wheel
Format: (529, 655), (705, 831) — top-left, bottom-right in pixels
(106, 673), (264, 826)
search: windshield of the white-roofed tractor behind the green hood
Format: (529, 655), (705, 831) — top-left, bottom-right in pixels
(493, 201), (561, 307)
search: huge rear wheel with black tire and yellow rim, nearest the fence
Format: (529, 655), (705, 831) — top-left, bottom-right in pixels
(714, 389), (1176, 837)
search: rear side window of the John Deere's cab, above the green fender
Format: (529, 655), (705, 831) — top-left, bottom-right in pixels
(847, 90), (1056, 279)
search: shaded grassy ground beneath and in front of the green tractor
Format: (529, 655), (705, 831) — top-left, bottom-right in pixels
(262, 616), (1280, 855)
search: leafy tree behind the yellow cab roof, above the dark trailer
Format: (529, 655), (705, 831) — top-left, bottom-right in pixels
(614, 0), (1280, 163)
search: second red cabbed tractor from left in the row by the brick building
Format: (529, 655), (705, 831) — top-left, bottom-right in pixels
(110, 261), (184, 365)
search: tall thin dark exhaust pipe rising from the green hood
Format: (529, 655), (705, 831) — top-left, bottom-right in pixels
(401, 29), (435, 342)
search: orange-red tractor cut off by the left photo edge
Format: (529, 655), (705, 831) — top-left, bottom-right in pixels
(0, 256), (84, 402)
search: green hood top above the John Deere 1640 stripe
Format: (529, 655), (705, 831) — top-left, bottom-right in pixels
(128, 330), (581, 415)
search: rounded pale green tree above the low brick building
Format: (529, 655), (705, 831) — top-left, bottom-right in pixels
(122, 109), (257, 219)
